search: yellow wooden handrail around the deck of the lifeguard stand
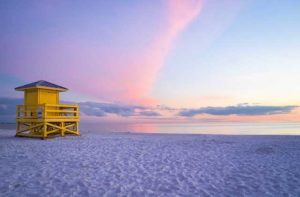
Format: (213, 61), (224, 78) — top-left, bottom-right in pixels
(16, 104), (79, 119)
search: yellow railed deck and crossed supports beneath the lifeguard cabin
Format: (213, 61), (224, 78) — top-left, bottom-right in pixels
(16, 104), (79, 139)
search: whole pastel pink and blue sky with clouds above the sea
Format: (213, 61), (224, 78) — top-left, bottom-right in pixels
(0, 0), (300, 122)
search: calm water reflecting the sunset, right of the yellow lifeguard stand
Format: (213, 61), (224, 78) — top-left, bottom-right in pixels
(80, 123), (300, 135)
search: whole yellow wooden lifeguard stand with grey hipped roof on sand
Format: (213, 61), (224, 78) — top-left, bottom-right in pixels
(15, 80), (79, 139)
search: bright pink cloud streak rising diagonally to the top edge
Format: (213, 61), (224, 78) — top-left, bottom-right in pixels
(105, 0), (202, 103)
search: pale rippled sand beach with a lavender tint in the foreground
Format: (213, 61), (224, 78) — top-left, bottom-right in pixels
(0, 130), (300, 196)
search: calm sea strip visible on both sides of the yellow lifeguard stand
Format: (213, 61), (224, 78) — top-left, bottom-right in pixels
(0, 122), (300, 136)
